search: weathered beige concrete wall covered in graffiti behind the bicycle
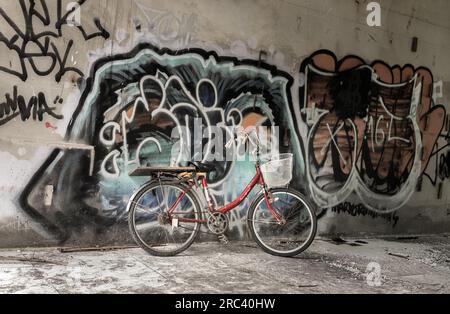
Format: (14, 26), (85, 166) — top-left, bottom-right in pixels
(0, 0), (450, 246)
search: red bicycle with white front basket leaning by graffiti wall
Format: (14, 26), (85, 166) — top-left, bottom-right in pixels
(128, 127), (317, 257)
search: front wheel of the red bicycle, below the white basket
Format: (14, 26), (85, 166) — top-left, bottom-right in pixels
(248, 189), (317, 257)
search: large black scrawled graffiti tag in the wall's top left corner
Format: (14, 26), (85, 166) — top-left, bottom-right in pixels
(0, 0), (109, 82)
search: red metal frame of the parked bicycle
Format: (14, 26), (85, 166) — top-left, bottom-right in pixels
(168, 163), (282, 223)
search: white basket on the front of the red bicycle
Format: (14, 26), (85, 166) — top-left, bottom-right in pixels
(261, 154), (294, 188)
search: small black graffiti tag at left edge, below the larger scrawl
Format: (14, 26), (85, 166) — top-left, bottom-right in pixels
(0, 86), (64, 126)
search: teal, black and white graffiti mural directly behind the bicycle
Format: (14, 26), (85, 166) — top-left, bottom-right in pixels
(22, 45), (304, 238)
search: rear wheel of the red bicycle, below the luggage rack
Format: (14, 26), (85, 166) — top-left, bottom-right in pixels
(128, 181), (201, 256)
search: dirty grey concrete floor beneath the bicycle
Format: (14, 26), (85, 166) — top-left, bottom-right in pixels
(0, 236), (450, 294)
